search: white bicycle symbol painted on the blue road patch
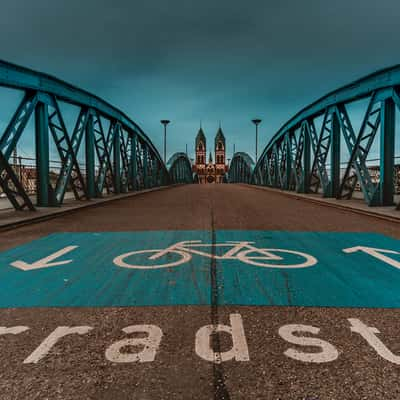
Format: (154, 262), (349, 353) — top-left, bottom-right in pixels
(113, 240), (318, 269)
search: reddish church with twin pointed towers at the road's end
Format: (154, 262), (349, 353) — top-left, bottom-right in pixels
(193, 126), (228, 184)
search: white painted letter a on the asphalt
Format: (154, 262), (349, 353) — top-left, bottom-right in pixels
(105, 325), (162, 363)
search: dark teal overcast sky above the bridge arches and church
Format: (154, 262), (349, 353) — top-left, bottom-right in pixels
(0, 0), (400, 163)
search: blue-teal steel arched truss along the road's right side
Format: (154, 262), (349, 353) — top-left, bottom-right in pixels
(252, 66), (400, 208)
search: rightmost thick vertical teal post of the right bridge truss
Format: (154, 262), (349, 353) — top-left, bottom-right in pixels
(373, 98), (396, 206)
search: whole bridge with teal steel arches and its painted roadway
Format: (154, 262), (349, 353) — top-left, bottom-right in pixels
(0, 62), (400, 400)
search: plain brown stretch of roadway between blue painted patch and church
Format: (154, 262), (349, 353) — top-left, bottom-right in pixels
(0, 185), (400, 249)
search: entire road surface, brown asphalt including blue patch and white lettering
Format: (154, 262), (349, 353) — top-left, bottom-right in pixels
(0, 185), (400, 400)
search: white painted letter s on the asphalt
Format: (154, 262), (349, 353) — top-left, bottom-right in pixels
(279, 324), (339, 363)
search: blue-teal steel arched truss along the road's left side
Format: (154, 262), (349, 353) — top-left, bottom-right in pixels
(0, 61), (170, 210)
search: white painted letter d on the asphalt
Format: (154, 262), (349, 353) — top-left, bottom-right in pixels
(195, 314), (250, 364)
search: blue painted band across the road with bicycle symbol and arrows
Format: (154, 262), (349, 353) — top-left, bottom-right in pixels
(0, 231), (400, 308)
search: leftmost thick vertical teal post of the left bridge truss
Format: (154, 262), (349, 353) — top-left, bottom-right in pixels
(35, 102), (51, 207)
